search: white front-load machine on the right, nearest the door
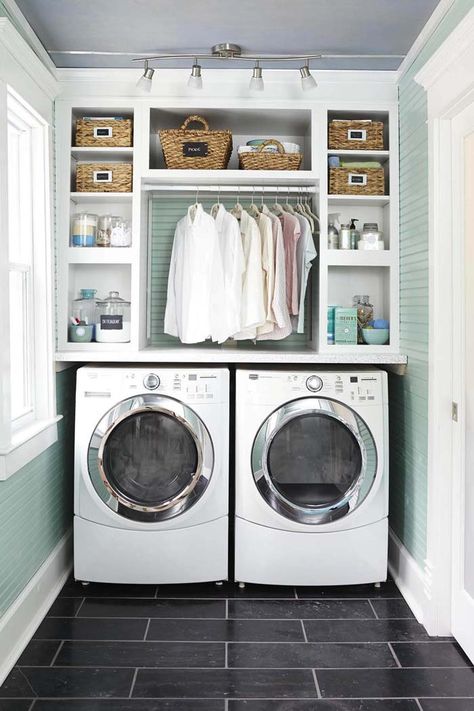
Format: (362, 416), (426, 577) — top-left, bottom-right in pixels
(235, 370), (388, 585)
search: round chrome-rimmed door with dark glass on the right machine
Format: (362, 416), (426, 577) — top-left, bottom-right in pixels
(252, 397), (377, 525)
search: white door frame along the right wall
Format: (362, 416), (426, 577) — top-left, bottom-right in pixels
(415, 10), (474, 635)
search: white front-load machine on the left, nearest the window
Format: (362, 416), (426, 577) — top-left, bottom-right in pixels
(74, 365), (229, 583)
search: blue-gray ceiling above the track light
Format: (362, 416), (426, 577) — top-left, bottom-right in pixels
(13, 0), (438, 70)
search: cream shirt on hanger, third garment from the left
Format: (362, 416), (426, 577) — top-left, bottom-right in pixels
(234, 207), (266, 340)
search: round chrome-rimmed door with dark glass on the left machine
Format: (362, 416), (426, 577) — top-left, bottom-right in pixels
(88, 394), (214, 522)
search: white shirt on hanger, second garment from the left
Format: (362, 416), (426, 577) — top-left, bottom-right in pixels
(211, 203), (245, 338)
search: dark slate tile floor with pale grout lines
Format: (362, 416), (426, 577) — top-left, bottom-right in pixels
(0, 580), (474, 711)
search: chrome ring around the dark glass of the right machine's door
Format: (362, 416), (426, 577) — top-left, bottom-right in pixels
(251, 397), (377, 525)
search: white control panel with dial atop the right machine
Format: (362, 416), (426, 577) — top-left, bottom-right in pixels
(238, 370), (387, 405)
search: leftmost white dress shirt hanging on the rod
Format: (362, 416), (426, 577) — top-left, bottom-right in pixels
(164, 205), (226, 343)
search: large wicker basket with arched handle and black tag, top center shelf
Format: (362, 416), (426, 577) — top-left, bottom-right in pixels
(160, 116), (232, 170)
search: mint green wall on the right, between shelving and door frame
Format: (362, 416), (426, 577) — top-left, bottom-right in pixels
(390, 0), (473, 566)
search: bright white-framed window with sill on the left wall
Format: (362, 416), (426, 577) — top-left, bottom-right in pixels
(0, 87), (57, 479)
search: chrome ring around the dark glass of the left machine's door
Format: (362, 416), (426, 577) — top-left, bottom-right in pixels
(88, 393), (214, 520)
